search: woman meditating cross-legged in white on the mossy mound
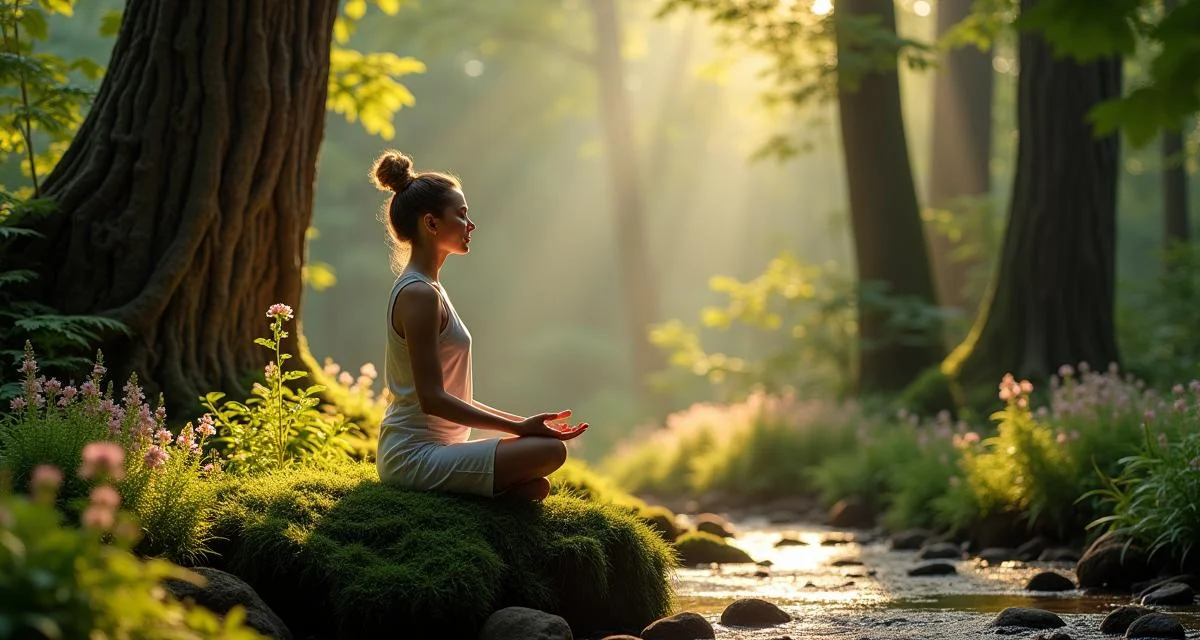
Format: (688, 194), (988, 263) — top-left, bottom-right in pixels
(372, 151), (588, 501)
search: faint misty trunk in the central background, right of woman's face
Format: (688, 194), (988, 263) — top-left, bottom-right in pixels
(592, 0), (662, 408)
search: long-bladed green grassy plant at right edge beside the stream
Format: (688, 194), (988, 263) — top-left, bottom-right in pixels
(1087, 429), (1200, 562)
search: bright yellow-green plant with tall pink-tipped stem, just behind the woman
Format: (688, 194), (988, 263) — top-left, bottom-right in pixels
(200, 304), (353, 474)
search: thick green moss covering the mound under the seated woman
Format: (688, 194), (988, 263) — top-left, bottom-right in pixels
(207, 463), (674, 638)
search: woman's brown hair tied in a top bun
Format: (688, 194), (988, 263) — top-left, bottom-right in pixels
(371, 150), (461, 273)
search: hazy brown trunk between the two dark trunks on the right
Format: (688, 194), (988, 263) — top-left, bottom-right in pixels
(925, 0), (994, 312)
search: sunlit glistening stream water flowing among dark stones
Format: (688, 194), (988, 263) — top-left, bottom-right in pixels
(657, 521), (1200, 640)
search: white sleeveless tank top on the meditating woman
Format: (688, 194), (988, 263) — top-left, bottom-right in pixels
(378, 271), (473, 449)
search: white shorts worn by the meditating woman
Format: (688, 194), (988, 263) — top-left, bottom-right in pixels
(376, 437), (500, 497)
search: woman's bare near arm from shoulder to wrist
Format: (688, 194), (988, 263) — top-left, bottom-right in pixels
(391, 283), (522, 435)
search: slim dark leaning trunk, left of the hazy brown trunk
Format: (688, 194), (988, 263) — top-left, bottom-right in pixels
(834, 0), (942, 391)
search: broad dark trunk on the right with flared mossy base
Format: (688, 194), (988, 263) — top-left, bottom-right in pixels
(946, 0), (1121, 390)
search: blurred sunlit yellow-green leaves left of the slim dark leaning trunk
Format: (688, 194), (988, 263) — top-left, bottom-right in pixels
(649, 252), (944, 400)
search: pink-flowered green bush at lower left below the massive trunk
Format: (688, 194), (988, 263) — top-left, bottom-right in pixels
(0, 346), (223, 562)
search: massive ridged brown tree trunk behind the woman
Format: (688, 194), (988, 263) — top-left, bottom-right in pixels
(14, 0), (337, 413)
